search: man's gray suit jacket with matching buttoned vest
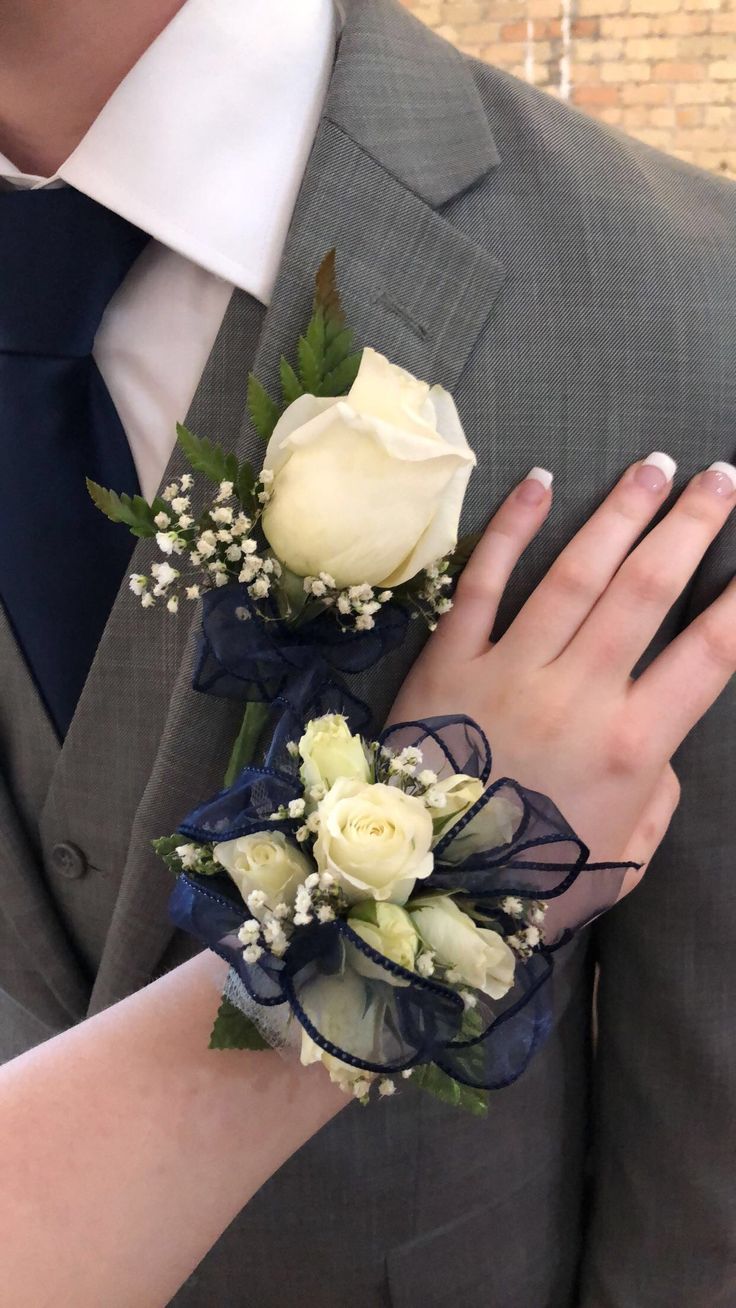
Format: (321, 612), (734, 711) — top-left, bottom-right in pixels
(0, 0), (736, 1308)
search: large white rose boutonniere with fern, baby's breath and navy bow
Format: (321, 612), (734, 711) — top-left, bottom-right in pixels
(88, 250), (476, 781)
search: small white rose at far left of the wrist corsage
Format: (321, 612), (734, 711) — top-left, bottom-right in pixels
(213, 831), (312, 910)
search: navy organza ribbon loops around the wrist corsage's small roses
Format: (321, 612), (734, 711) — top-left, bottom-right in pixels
(170, 717), (635, 1090)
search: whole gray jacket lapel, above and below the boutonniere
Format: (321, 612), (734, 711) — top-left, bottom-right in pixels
(93, 0), (503, 1010)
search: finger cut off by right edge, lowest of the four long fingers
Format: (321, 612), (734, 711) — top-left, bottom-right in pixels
(629, 579), (736, 755)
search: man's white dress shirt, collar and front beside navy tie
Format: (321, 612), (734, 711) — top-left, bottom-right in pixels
(0, 0), (339, 498)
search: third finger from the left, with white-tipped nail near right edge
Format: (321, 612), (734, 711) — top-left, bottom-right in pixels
(565, 463), (736, 676)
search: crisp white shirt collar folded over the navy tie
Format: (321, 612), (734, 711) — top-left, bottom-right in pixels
(0, 0), (340, 303)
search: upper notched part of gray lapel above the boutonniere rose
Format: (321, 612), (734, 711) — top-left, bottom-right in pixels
(241, 0), (505, 423)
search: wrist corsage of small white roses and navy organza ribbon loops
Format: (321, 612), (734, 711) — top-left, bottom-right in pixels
(161, 714), (640, 1112)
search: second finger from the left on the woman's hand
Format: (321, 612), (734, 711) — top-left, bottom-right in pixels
(503, 451), (676, 667)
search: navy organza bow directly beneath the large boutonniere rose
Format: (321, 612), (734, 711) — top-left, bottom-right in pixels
(193, 585), (408, 730)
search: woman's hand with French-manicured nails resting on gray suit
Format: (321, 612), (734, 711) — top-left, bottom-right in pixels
(391, 455), (736, 893)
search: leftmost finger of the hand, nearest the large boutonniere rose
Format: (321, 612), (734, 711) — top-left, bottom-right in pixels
(431, 468), (552, 659)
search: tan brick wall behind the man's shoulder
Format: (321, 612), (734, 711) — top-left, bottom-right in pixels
(404, 0), (736, 178)
